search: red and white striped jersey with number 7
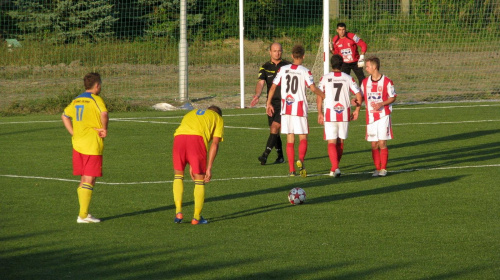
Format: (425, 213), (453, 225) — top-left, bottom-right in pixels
(319, 72), (360, 122)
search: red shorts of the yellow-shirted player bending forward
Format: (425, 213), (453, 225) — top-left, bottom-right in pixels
(172, 135), (207, 174)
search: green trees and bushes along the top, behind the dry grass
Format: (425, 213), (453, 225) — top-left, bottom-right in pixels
(0, 0), (500, 43)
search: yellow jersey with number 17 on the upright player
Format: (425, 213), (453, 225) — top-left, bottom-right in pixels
(64, 92), (108, 155)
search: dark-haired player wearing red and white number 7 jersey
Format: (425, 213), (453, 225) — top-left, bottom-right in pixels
(316, 54), (362, 177)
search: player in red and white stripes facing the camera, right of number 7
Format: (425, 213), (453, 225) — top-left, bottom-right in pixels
(361, 57), (396, 177)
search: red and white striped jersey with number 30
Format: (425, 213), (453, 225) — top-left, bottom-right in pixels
(273, 64), (314, 117)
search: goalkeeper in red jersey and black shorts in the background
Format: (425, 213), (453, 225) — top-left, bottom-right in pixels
(330, 22), (368, 84)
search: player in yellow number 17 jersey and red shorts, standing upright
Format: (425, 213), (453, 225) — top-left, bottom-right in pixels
(61, 73), (109, 224)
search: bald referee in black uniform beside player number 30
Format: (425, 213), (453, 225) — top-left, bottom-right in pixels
(250, 43), (291, 165)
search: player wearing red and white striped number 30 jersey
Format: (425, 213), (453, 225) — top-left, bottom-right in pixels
(266, 45), (325, 177)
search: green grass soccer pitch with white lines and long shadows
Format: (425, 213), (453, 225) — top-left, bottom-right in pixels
(0, 102), (500, 279)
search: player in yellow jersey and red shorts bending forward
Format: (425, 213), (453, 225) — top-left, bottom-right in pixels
(172, 106), (224, 225)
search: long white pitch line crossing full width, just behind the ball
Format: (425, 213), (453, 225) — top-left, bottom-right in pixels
(0, 164), (500, 185)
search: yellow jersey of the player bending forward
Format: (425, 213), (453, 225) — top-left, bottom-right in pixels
(174, 109), (224, 150)
